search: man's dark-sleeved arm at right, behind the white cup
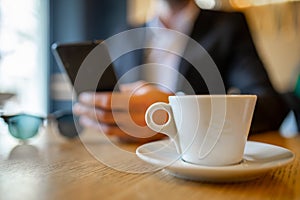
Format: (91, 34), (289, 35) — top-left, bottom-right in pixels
(227, 13), (288, 132)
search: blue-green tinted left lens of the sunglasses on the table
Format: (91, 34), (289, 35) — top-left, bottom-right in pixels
(3, 114), (43, 140)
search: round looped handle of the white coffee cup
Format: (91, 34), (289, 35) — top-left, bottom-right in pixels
(145, 102), (182, 154)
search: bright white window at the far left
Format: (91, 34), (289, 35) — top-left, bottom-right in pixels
(0, 0), (49, 115)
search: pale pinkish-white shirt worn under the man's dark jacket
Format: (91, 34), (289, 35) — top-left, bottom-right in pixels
(142, 2), (200, 93)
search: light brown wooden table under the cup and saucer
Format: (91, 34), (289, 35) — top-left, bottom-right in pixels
(0, 122), (300, 200)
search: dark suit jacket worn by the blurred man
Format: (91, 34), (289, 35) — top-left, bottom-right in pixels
(115, 10), (288, 132)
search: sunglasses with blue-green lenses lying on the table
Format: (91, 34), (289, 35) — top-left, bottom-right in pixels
(0, 111), (82, 140)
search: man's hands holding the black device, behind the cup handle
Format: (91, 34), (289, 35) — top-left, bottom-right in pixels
(73, 82), (172, 143)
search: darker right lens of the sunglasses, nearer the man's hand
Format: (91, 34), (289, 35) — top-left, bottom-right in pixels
(56, 113), (82, 138)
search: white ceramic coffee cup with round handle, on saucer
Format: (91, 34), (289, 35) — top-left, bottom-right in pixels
(145, 95), (257, 166)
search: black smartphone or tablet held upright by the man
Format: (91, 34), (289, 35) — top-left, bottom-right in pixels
(51, 40), (117, 94)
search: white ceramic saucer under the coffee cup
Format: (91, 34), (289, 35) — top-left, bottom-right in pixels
(136, 140), (294, 182)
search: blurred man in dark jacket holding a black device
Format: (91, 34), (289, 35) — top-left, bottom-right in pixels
(74, 0), (288, 142)
